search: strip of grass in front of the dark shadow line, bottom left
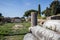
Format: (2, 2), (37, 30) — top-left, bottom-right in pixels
(0, 35), (24, 40)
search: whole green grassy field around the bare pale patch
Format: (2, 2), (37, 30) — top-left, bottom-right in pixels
(0, 22), (30, 40)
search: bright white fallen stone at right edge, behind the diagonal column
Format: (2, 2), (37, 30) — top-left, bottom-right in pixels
(43, 20), (60, 33)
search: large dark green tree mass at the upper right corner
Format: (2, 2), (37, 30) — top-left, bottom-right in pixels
(42, 1), (60, 17)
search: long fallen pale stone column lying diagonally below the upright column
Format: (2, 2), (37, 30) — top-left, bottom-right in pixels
(30, 26), (60, 40)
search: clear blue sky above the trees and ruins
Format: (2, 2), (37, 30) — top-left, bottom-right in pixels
(0, 0), (53, 17)
